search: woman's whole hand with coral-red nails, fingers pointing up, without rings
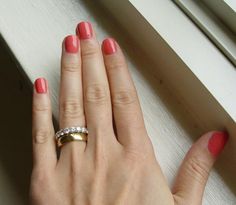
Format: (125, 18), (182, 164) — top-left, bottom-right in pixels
(30, 22), (227, 205)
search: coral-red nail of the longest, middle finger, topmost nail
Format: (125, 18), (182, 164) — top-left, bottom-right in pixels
(76, 22), (93, 39)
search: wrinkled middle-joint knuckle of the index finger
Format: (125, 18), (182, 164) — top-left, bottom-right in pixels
(112, 90), (137, 106)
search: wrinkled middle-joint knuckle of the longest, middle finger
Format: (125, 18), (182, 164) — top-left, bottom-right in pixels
(85, 84), (108, 104)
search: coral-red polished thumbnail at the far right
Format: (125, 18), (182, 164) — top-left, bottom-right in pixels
(208, 132), (228, 156)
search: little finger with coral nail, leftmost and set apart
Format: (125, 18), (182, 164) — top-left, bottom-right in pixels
(32, 78), (57, 171)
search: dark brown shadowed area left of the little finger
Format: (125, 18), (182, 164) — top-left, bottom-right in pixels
(0, 39), (32, 205)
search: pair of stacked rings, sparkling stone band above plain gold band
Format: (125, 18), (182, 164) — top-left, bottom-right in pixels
(55, 127), (88, 147)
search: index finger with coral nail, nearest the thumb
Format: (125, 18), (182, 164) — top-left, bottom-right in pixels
(102, 38), (147, 146)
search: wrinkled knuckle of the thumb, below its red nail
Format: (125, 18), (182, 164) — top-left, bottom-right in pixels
(186, 157), (210, 183)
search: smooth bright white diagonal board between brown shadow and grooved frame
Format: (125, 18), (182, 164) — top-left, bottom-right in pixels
(129, 0), (236, 121)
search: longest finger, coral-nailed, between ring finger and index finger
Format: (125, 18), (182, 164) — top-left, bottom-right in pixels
(76, 22), (114, 144)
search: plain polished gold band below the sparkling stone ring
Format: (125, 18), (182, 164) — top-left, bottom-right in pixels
(57, 133), (87, 147)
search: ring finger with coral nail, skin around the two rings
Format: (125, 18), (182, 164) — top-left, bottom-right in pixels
(60, 35), (86, 152)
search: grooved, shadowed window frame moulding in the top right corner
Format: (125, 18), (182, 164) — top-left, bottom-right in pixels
(173, 0), (236, 65)
